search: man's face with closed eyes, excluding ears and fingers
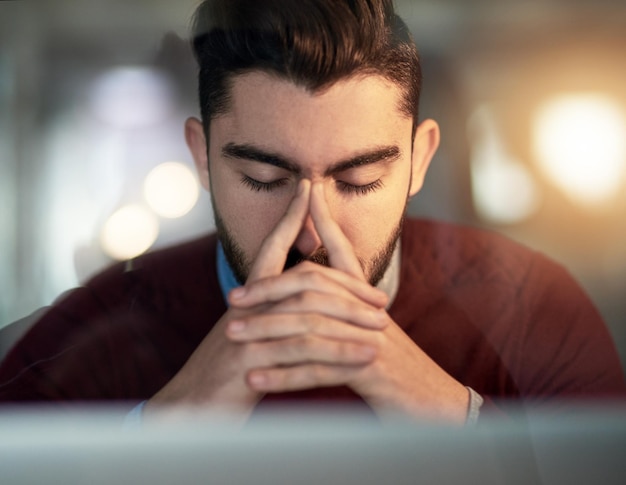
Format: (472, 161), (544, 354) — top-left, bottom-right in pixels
(202, 72), (422, 284)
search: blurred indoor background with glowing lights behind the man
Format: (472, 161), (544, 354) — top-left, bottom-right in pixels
(0, 0), (626, 372)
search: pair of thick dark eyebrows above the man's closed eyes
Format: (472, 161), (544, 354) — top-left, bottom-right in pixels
(222, 142), (400, 176)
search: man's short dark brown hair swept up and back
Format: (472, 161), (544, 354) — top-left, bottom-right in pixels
(192, 0), (421, 132)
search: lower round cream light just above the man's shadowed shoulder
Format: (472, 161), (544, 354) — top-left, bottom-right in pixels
(100, 205), (159, 260)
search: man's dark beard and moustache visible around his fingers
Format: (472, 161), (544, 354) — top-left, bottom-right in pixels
(213, 202), (404, 286)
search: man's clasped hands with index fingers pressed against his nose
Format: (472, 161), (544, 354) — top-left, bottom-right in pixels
(151, 180), (468, 423)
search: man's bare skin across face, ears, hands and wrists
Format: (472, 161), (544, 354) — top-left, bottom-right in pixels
(146, 72), (468, 424)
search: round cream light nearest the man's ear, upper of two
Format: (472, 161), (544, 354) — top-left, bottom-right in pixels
(144, 162), (200, 218)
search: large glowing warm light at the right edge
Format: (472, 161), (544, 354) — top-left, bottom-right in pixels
(533, 93), (626, 205)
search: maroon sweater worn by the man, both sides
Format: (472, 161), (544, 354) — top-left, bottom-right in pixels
(0, 220), (626, 412)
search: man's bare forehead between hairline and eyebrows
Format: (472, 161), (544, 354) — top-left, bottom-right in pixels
(209, 72), (412, 169)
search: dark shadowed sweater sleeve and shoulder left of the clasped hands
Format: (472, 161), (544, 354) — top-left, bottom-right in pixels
(0, 236), (221, 407)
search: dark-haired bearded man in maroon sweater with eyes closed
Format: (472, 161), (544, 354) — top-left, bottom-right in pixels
(0, 0), (624, 424)
